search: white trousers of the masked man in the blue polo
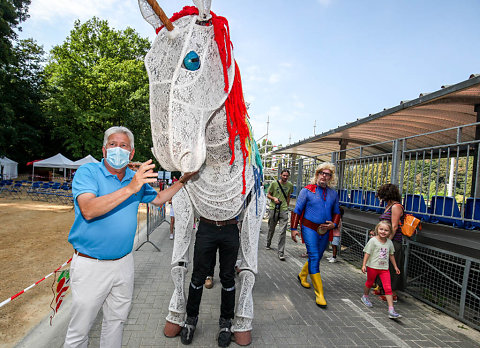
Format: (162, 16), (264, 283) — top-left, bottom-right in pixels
(64, 253), (134, 348)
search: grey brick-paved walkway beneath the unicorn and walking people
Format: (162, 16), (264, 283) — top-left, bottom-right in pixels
(18, 219), (480, 348)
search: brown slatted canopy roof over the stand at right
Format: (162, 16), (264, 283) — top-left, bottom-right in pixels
(273, 74), (480, 160)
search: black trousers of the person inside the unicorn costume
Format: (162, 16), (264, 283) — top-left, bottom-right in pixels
(187, 221), (240, 319)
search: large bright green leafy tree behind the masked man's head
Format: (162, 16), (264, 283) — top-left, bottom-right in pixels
(45, 17), (152, 161)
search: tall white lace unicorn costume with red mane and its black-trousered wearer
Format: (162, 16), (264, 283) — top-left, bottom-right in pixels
(139, 0), (266, 347)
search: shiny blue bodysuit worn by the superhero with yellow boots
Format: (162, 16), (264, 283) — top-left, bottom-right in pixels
(294, 185), (340, 274)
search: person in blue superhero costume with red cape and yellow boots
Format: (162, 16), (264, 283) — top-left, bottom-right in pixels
(290, 162), (340, 308)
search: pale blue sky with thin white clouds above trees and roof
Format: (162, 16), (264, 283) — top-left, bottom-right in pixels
(17, 0), (480, 145)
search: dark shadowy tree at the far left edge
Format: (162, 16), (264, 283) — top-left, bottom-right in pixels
(0, 0), (45, 165)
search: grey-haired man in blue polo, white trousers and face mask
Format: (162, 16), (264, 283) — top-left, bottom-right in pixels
(64, 127), (196, 348)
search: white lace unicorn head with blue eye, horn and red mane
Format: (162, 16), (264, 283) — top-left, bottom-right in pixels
(139, 0), (248, 172)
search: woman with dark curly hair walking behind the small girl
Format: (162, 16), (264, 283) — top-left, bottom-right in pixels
(375, 184), (405, 302)
